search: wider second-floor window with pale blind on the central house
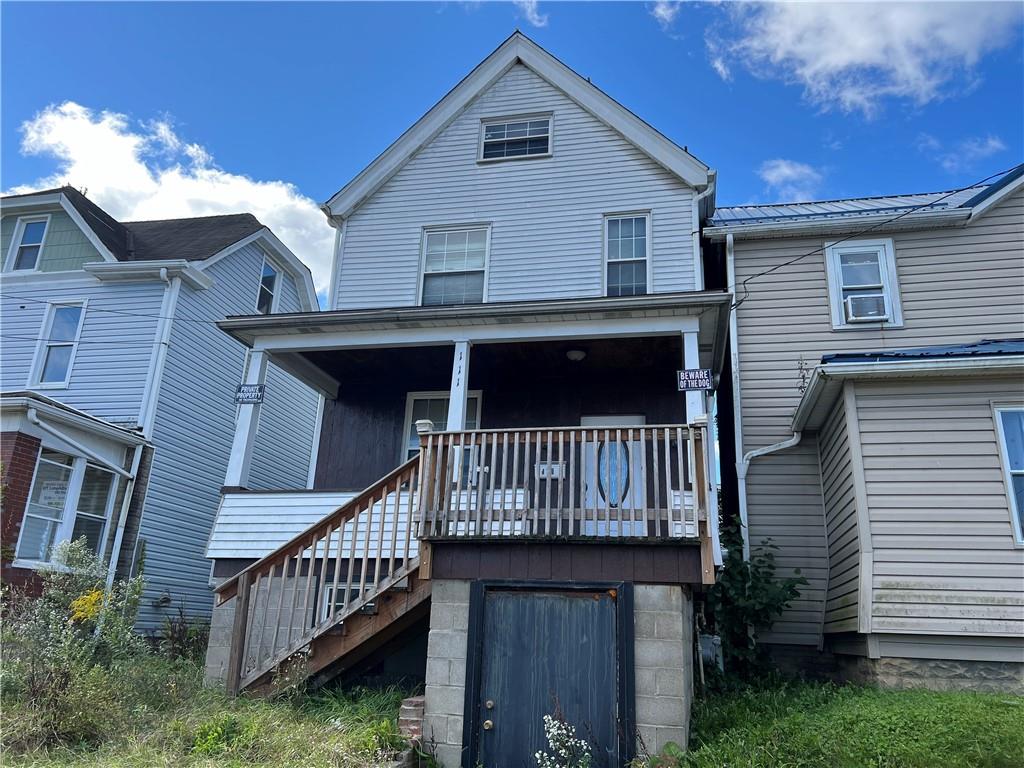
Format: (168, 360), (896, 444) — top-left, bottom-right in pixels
(423, 227), (488, 306)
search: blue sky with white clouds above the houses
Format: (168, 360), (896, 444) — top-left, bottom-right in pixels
(0, 2), (1024, 290)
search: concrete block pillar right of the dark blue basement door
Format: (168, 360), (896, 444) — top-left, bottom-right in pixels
(633, 584), (693, 755)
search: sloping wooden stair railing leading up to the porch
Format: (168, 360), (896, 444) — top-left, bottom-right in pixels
(216, 456), (420, 694)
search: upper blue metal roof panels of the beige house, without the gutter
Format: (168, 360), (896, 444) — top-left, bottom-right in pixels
(708, 164), (1024, 226)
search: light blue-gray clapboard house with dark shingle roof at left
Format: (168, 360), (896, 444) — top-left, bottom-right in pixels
(0, 186), (317, 630)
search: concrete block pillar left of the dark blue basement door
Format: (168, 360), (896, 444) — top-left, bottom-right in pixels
(423, 580), (470, 768)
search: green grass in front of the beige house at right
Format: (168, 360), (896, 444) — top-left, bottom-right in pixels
(683, 684), (1024, 768)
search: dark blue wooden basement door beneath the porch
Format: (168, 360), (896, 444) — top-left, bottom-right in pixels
(469, 587), (632, 768)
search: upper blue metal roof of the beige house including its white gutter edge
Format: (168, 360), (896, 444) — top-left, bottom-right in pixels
(705, 163), (1024, 237)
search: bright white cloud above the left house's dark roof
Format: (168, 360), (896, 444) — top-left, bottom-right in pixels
(7, 101), (334, 293)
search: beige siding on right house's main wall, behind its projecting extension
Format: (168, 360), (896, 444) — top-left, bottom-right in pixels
(735, 191), (1024, 644)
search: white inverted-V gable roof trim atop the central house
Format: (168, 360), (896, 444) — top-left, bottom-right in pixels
(321, 30), (713, 219)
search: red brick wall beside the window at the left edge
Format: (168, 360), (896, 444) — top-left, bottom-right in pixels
(0, 432), (40, 588)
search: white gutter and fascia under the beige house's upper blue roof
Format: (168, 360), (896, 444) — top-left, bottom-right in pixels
(703, 208), (971, 242)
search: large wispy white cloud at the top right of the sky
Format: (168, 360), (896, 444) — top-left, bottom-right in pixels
(708, 2), (1024, 117)
